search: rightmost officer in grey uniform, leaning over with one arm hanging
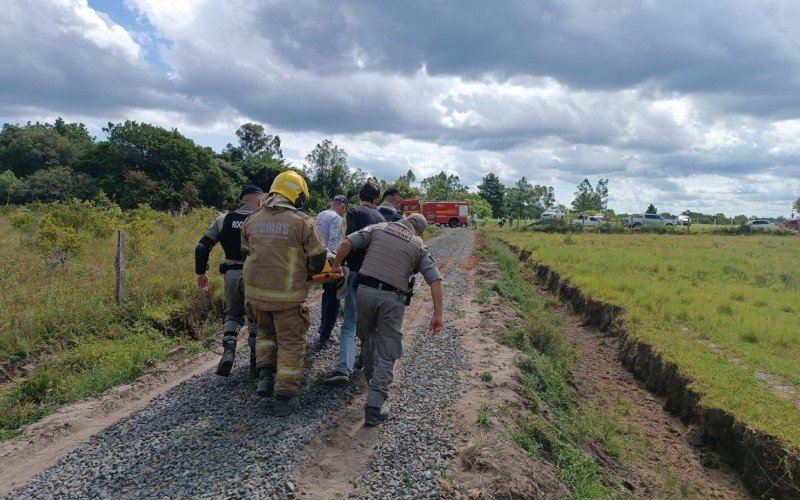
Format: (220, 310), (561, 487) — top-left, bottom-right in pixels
(331, 213), (444, 427)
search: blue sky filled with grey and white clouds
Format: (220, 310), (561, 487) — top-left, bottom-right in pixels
(0, 0), (800, 216)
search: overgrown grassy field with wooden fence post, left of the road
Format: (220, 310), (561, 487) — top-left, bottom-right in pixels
(0, 205), (222, 438)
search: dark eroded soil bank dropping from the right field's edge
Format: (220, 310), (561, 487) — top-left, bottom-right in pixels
(511, 246), (800, 499)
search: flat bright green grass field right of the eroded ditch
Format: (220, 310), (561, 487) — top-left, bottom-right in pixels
(484, 229), (800, 450)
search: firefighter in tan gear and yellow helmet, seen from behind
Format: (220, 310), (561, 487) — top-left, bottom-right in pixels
(242, 170), (327, 417)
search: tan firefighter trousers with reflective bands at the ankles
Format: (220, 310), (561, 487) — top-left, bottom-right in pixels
(248, 303), (311, 396)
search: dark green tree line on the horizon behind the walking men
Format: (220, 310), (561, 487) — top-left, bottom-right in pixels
(0, 118), (554, 217)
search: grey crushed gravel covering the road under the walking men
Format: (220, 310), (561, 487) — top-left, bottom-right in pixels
(2, 229), (475, 499)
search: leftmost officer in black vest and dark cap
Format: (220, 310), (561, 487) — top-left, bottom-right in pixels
(194, 186), (264, 377)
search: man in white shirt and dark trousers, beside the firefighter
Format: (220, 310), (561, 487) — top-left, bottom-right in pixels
(317, 194), (347, 348)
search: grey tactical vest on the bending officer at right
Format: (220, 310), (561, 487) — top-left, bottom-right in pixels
(359, 222), (423, 291)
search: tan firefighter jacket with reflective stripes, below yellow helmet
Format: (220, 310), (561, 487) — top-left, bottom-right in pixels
(242, 194), (327, 311)
